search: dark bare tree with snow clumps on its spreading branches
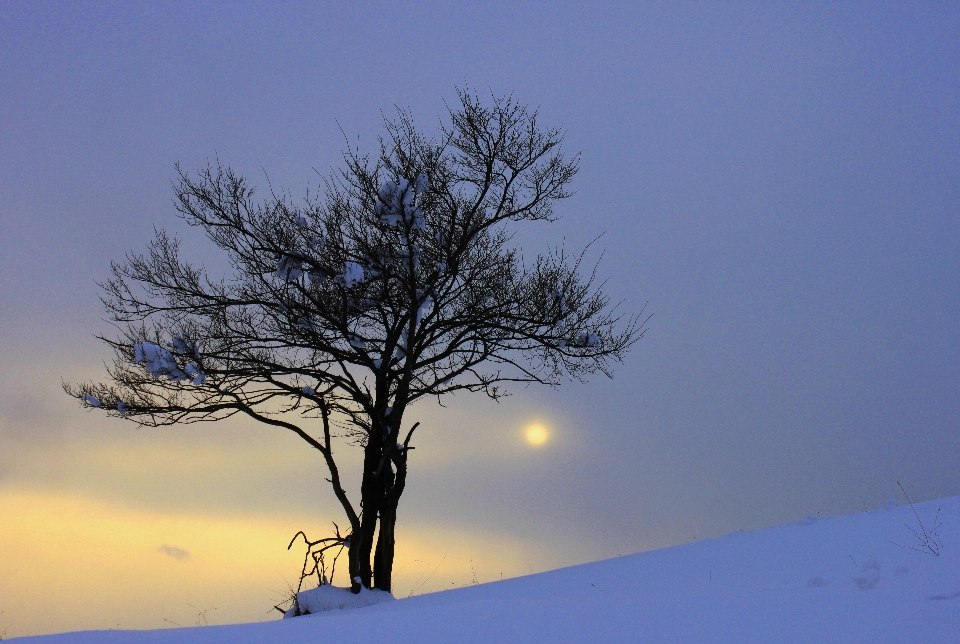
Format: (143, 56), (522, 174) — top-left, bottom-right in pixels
(65, 91), (643, 592)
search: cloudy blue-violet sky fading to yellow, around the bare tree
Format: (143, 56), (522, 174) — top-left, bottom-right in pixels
(0, 1), (960, 637)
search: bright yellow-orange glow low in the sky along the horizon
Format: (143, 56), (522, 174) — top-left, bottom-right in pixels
(0, 488), (552, 637)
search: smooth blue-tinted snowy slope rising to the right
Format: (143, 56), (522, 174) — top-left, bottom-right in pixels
(15, 497), (960, 644)
